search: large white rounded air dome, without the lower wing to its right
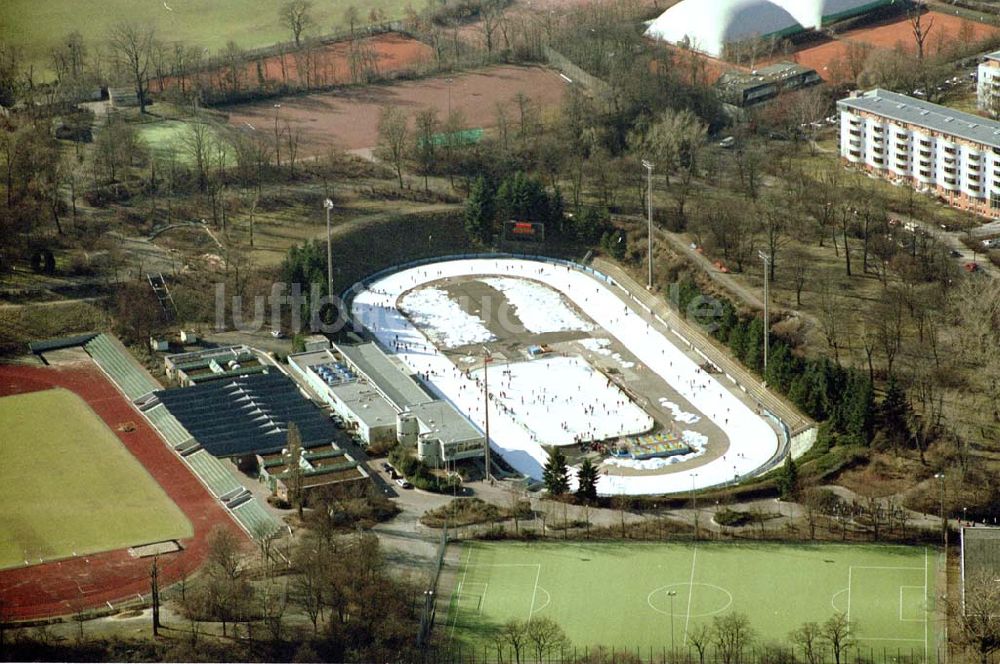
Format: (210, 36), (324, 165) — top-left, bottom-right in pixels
(646, 0), (814, 57)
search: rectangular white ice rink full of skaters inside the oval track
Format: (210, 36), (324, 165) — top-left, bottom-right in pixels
(474, 356), (654, 445)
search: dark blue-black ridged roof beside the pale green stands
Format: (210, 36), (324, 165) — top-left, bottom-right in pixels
(156, 373), (334, 457)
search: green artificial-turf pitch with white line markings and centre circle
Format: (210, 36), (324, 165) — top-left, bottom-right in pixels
(437, 543), (940, 661)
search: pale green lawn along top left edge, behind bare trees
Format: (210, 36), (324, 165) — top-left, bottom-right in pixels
(0, 0), (407, 72)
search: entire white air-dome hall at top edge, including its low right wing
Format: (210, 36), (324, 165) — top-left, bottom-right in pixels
(646, 0), (894, 57)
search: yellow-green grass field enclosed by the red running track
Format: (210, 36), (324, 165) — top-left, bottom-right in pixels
(0, 389), (193, 569)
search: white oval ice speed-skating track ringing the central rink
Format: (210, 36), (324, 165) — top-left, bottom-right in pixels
(352, 259), (778, 495)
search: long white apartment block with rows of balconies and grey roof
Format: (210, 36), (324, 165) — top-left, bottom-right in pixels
(837, 88), (1000, 217)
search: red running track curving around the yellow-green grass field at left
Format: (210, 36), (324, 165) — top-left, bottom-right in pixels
(0, 362), (246, 620)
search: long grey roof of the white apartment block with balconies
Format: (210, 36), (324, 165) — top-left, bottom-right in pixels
(837, 88), (1000, 147)
